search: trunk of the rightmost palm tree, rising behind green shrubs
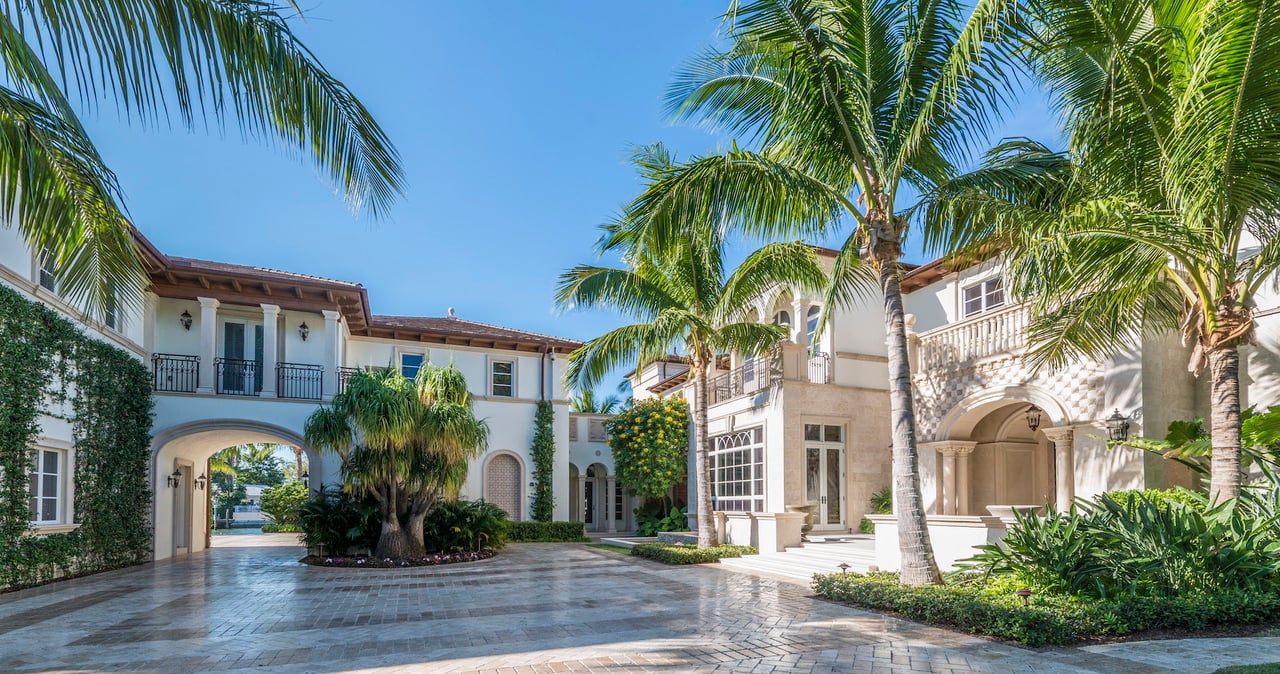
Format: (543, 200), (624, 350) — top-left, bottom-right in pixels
(1208, 344), (1240, 501)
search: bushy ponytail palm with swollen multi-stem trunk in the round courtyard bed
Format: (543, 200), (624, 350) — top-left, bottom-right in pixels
(305, 364), (489, 559)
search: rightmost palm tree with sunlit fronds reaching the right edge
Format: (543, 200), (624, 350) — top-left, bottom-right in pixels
(925, 0), (1280, 499)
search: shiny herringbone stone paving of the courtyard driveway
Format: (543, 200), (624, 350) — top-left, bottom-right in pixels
(0, 535), (1280, 674)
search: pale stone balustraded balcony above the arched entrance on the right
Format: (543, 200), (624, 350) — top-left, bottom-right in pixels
(915, 304), (1028, 372)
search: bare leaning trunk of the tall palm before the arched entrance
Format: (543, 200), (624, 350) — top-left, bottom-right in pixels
(877, 260), (942, 586)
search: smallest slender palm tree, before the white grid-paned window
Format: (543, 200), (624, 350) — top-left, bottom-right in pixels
(556, 237), (826, 547)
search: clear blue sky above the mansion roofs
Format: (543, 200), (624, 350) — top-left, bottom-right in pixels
(87, 0), (1052, 396)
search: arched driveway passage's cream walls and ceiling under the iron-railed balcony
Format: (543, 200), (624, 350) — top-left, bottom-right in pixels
(151, 418), (322, 560)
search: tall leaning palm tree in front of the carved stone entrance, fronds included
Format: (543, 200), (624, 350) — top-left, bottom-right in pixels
(605, 0), (1010, 584)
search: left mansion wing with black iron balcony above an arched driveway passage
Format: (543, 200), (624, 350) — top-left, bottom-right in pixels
(0, 228), (596, 559)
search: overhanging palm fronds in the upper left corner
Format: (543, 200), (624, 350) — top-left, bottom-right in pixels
(0, 0), (402, 312)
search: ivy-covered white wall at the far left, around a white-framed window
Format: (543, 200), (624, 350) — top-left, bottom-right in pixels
(0, 285), (152, 590)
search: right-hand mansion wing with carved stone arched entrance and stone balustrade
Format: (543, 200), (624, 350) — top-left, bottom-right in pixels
(630, 249), (1280, 569)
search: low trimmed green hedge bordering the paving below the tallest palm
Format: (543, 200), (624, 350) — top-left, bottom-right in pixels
(813, 573), (1280, 647)
